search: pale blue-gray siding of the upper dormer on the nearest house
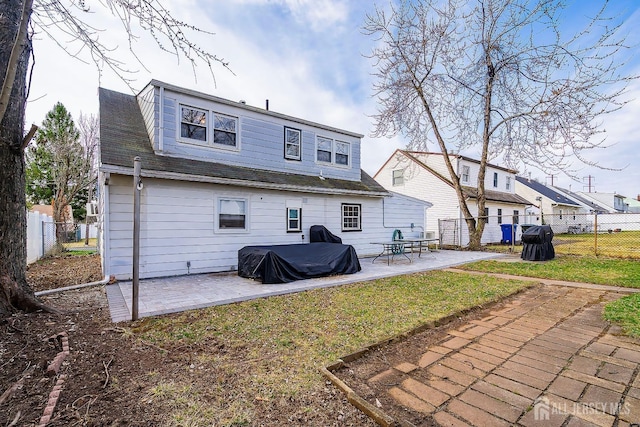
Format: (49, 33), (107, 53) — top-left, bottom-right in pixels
(143, 90), (361, 181)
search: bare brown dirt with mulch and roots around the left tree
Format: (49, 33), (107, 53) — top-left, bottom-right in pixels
(0, 255), (374, 427)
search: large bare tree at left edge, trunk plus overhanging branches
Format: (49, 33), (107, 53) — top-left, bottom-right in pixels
(0, 0), (228, 316)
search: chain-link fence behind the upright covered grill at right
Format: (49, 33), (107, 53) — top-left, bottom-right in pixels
(438, 213), (640, 259)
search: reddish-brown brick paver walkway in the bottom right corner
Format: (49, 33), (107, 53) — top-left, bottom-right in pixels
(368, 286), (640, 426)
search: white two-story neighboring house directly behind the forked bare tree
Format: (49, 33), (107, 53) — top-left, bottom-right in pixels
(374, 150), (530, 246)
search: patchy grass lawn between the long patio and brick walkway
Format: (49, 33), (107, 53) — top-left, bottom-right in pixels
(131, 271), (528, 425)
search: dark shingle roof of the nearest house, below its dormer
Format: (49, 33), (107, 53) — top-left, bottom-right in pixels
(99, 88), (388, 196)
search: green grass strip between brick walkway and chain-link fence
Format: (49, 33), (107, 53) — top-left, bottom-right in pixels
(461, 255), (640, 288)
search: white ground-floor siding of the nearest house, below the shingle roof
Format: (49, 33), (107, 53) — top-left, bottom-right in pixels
(104, 174), (425, 280)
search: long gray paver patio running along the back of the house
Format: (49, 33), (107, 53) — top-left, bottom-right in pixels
(106, 250), (502, 322)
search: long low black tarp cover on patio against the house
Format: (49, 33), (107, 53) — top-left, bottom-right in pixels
(238, 242), (361, 284)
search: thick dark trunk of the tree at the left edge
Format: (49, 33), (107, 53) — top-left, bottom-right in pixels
(0, 0), (45, 317)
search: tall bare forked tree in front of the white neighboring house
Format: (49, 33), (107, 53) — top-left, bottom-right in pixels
(364, 0), (635, 249)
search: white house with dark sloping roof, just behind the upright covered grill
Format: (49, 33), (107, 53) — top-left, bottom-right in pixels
(516, 176), (588, 234)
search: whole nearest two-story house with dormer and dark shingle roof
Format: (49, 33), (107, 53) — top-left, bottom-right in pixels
(99, 80), (429, 279)
